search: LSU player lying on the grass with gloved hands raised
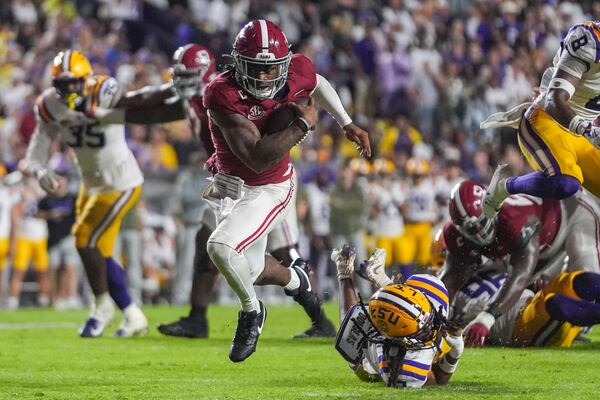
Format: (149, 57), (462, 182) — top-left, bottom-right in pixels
(331, 246), (464, 388)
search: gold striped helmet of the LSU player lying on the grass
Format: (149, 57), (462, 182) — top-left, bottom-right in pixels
(369, 284), (435, 347)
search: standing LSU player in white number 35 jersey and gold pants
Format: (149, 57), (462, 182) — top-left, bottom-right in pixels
(25, 50), (148, 337)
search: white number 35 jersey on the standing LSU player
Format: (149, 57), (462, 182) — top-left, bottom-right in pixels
(27, 76), (143, 192)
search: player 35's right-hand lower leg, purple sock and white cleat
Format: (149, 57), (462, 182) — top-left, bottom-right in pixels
(106, 257), (148, 337)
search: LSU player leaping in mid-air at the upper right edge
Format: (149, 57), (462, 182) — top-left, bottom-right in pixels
(483, 22), (600, 218)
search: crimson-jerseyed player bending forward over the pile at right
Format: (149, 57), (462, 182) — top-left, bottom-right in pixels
(441, 181), (600, 346)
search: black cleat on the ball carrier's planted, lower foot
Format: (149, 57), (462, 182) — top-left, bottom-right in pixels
(229, 300), (267, 362)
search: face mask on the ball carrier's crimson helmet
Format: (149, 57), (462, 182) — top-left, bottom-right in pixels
(232, 51), (292, 100)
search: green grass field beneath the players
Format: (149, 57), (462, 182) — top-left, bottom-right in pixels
(0, 304), (600, 400)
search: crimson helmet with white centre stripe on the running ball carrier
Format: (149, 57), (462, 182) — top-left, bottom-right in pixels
(231, 19), (292, 100)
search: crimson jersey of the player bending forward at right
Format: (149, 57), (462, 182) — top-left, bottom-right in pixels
(444, 195), (562, 260)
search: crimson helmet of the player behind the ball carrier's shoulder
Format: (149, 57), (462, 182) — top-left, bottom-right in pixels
(171, 43), (216, 99)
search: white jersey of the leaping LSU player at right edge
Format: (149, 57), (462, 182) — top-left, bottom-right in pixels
(540, 22), (600, 121)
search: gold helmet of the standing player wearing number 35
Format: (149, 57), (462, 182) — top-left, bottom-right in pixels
(51, 50), (94, 109)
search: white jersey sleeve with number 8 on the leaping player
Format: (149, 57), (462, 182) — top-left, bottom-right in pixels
(556, 24), (600, 78)
